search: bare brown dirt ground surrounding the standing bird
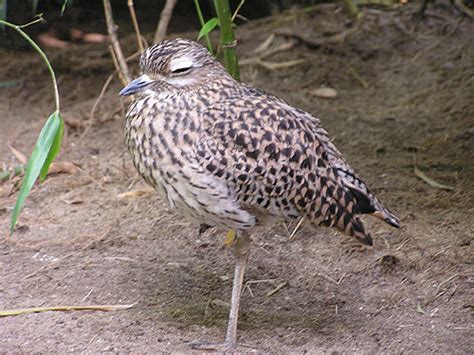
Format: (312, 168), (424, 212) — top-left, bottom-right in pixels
(0, 3), (474, 354)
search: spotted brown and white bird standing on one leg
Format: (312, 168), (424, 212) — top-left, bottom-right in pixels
(120, 38), (400, 350)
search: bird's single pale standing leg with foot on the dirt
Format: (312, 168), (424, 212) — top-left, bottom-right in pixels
(192, 234), (251, 351)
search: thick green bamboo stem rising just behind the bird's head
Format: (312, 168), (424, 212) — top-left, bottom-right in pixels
(214, 0), (240, 81)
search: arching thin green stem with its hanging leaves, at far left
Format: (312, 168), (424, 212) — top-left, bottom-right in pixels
(0, 18), (64, 235)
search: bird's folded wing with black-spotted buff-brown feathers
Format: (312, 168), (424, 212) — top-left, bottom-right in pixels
(196, 95), (371, 244)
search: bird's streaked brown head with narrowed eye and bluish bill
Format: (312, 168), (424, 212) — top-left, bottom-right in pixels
(120, 38), (226, 96)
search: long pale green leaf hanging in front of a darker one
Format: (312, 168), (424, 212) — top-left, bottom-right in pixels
(10, 111), (62, 235)
